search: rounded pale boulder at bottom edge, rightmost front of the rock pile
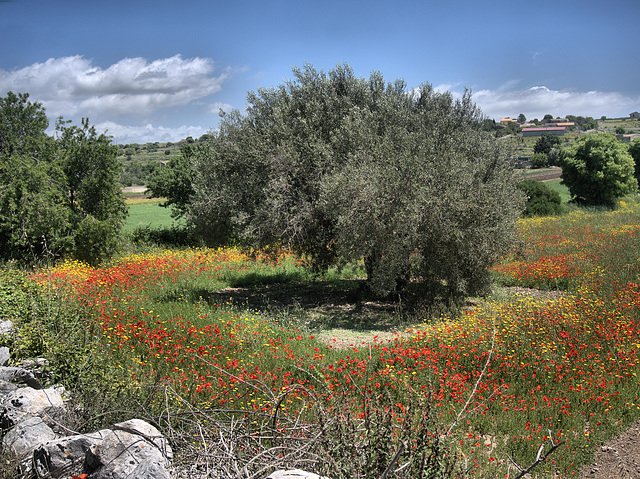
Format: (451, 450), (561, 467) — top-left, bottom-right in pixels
(85, 430), (169, 479)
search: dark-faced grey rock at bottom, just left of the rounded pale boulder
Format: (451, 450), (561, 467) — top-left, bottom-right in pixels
(33, 429), (111, 477)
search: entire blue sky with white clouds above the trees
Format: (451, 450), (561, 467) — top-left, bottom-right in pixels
(0, 0), (640, 144)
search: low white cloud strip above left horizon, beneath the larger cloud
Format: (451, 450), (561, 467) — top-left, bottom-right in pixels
(95, 121), (209, 145)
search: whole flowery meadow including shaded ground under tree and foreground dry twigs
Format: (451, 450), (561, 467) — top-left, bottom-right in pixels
(3, 198), (640, 478)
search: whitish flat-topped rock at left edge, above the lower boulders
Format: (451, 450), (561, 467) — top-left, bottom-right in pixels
(0, 387), (64, 429)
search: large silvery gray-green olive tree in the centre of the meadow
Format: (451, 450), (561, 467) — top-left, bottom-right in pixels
(188, 65), (523, 295)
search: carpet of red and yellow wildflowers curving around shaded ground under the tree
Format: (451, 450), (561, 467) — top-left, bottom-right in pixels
(15, 201), (640, 478)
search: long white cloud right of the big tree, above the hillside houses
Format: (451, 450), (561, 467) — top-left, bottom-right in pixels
(472, 86), (640, 119)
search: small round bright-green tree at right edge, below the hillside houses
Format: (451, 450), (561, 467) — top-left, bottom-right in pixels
(559, 133), (638, 206)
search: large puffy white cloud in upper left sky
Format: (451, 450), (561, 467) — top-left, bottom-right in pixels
(0, 55), (229, 118)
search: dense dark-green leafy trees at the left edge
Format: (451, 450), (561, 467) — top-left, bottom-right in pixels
(0, 92), (126, 262)
